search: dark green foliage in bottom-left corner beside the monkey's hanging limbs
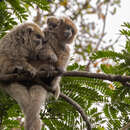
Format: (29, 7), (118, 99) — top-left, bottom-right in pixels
(0, 91), (23, 130)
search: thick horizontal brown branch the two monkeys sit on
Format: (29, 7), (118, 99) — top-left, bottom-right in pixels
(0, 71), (130, 87)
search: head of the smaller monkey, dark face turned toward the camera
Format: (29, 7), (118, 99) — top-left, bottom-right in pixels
(47, 16), (77, 44)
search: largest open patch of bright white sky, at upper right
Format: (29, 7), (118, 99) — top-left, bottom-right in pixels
(106, 0), (130, 51)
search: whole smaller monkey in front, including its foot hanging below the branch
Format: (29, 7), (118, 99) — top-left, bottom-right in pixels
(35, 16), (77, 98)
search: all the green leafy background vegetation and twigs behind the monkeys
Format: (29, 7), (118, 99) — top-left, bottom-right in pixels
(0, 0), (130, 130)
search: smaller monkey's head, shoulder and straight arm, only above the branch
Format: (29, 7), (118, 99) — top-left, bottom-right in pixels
(44, 16), (77, 72)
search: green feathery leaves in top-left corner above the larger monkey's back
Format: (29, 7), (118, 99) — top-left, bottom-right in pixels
(0, 0), (50, 38)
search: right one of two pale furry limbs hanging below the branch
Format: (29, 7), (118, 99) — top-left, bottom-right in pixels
(25, 85), (47, 130)
